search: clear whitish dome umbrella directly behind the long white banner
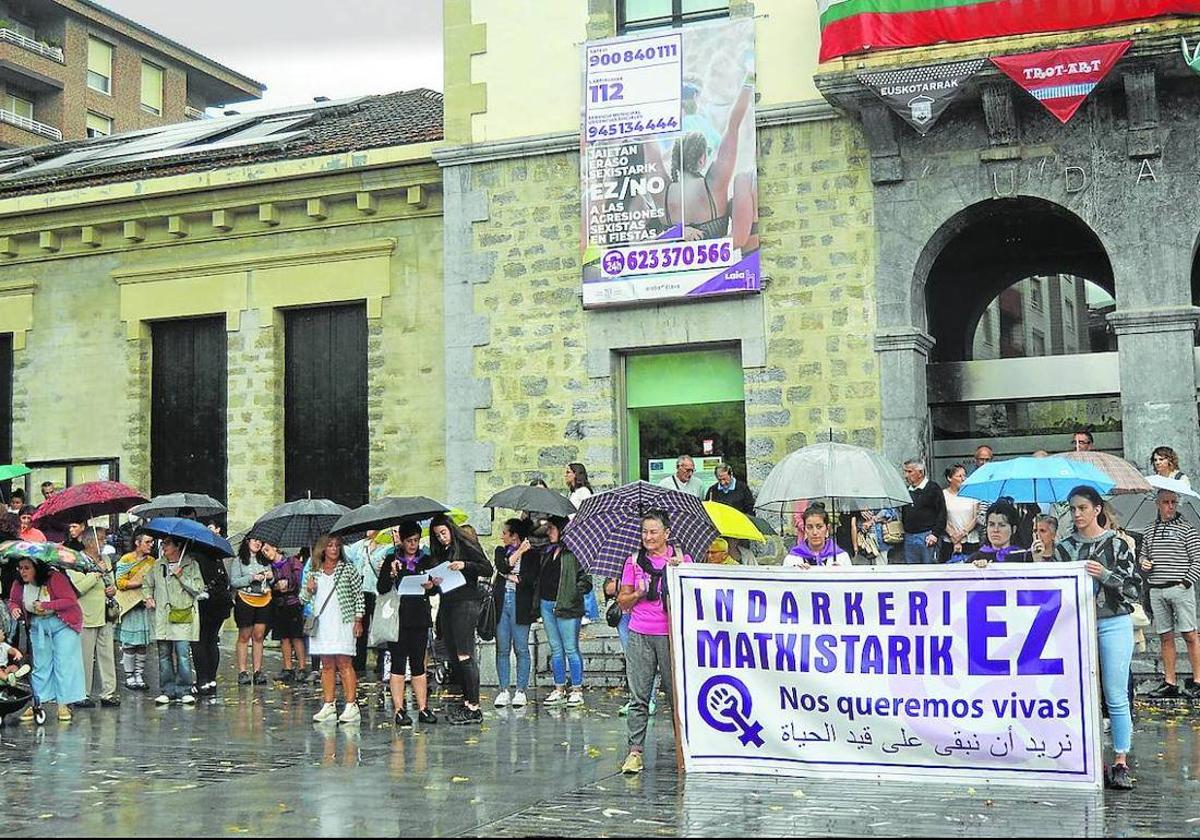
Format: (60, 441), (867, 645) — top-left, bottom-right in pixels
(755, 443), (912, 517)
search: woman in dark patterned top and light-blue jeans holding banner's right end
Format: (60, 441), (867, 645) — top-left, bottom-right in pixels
(1055, 486), (1140, 791)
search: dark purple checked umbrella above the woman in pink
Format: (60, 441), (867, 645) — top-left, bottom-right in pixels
(563, 481), (720, 577)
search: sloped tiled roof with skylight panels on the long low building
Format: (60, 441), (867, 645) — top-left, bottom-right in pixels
(0, 88), (443, 197)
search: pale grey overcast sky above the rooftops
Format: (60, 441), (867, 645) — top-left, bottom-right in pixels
(100, 0), (442, 110)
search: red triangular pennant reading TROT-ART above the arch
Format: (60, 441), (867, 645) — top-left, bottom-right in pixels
(991, 41), (1133, 125)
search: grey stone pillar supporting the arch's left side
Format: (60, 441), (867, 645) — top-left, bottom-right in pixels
(875, 326), (934, 464)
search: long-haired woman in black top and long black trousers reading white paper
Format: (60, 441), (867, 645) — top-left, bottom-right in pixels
(430, 514), (492, 726)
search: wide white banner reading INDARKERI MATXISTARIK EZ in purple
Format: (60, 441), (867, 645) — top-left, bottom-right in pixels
(668, 563), (1102, 788)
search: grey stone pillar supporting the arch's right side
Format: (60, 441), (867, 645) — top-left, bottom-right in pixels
(1109, 306), (1200, 473)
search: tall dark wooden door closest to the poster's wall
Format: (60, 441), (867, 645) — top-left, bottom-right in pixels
(283, 304), (370, 508)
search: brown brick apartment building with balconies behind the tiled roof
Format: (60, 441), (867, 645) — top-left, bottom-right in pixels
(0, 0), (264, 149)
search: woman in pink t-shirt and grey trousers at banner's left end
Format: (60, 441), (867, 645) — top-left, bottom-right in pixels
(617, 511), (691, 774)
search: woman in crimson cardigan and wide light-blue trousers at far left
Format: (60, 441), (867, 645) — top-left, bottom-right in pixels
(8, 557), (88, 721)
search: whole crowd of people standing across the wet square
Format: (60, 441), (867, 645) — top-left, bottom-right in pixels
(0, 444), (1200, 788)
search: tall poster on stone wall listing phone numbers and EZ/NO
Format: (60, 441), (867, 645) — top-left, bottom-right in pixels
(580, 19), (761, 307)
